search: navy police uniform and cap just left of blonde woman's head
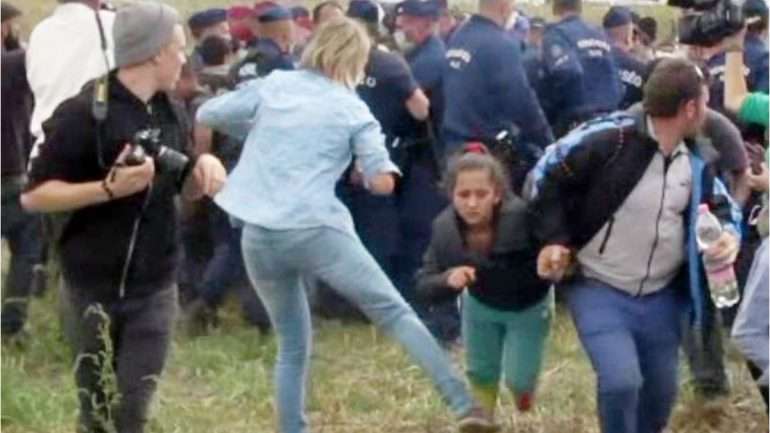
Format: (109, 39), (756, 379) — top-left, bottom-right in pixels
(231, 6), (294, 83)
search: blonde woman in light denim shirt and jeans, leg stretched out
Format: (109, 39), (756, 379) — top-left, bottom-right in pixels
(198, 18), (496, 433)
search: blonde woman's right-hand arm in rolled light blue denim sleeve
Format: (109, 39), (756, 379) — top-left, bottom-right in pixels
(350, 109), (401, 195)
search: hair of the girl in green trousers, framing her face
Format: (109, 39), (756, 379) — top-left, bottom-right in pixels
(443, 143), (511, 200)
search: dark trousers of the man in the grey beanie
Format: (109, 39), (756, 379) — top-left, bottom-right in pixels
(61, 282), (177, 433)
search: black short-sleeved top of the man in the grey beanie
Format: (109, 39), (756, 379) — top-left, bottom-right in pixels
(28, 72), (187, 300)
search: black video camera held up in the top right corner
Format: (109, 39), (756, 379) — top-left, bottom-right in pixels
(668, 0), (745, 47)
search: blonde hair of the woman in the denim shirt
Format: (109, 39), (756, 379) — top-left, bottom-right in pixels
(300, 17), (371, 89)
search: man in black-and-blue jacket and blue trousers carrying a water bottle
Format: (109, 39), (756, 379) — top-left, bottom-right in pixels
(533, 59), (740, 433)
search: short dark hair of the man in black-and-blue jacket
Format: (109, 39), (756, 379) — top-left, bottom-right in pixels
(642, 59), (706, 117)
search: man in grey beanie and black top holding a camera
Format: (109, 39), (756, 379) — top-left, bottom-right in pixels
(22, 2), (226, 433)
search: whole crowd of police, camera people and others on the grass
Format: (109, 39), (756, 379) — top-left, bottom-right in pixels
(1, 0), (770, 433)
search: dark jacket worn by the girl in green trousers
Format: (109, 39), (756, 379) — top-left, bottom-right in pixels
(417, 196), (548, 310)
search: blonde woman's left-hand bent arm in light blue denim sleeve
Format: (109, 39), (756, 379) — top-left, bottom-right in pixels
(196, 80), (260, 140)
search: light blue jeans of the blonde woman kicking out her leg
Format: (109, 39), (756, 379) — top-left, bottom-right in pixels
(241, 225), (472, 433)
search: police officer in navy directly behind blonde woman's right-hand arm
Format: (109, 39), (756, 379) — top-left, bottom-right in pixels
(339, 0), (430, 308)
